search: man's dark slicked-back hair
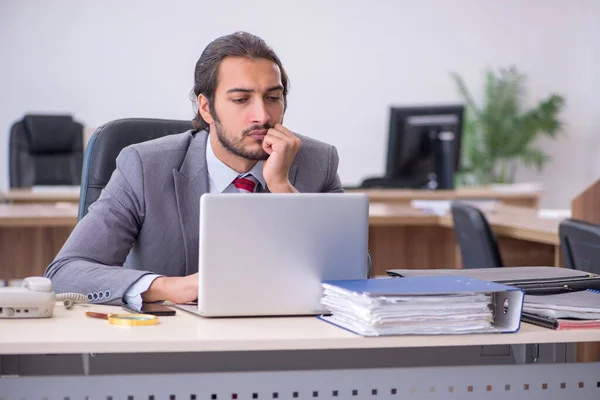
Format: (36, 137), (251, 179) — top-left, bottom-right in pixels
(192, 32), (289, 130)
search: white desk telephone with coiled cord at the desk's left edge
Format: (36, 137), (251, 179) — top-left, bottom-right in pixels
(0, 276), (87, 318)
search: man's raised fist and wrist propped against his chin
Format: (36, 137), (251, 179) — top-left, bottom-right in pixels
(263, 124), (302, 193)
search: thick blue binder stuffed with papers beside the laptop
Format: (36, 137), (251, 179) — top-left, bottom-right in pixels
(319, 277), (523, 336)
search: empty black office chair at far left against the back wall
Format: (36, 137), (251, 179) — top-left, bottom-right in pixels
(8, 115), (83, 188)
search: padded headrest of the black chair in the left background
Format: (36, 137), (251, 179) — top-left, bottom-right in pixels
(23, 115), (83, 154)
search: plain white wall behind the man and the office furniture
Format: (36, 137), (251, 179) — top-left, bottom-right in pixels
(0, 0), (600, 207)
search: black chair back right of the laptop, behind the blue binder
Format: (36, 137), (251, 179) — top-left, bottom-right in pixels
(451, 202), (503, 269)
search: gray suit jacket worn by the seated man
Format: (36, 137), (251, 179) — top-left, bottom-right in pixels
(45, 131), (342, 304)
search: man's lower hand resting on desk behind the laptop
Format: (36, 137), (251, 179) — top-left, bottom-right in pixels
(142, 273), (198, 304)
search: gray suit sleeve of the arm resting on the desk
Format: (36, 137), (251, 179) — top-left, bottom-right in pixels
(44, 147), (155, 305)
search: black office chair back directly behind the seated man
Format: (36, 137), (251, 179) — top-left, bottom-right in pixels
(78, 118), (192, 220)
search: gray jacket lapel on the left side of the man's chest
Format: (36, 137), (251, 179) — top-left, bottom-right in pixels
(173, 131), (209, 275)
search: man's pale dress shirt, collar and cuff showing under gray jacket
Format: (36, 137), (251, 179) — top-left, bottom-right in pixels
(123, 135), (267, 304)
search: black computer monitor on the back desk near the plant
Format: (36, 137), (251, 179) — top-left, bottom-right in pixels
(380, 105), (464, 189)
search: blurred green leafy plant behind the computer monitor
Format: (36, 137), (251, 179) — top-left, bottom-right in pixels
(452, 67), (564, 185)
